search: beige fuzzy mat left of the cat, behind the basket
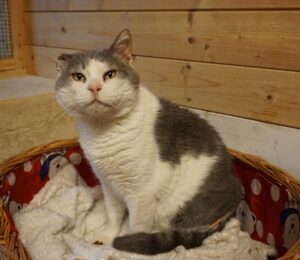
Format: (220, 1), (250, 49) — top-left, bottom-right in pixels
(0, 94), (77, 163)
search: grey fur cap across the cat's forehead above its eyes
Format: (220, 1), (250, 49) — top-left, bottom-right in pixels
(56, 49), (140, 89)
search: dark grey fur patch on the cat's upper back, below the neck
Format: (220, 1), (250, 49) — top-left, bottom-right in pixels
(154, 99), (224, 164)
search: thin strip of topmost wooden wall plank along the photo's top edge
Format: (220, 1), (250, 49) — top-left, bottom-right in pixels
(26, 0), (300, 11)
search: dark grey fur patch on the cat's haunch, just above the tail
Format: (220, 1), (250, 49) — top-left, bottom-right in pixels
(171, 151), (242, 228)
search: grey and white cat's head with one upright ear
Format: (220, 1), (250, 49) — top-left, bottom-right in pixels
(56, 29), (140, 118)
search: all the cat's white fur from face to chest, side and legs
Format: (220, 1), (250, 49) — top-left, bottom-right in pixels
(57, 61), (216, 243)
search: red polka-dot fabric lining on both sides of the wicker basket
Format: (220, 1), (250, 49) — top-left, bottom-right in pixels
(0, 147), (300, 256)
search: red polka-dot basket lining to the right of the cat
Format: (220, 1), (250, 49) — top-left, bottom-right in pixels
(235, 161), (300, 256)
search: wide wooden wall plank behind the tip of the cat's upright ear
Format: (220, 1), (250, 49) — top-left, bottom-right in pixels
(26, 11), (300, 71)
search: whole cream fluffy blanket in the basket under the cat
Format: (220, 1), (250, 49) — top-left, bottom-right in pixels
(14, 164), (276, 260)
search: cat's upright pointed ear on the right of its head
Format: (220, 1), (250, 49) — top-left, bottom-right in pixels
(110, 29), (132, 63)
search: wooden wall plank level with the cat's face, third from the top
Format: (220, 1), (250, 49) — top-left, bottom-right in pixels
(33, 46), (300, 128)
